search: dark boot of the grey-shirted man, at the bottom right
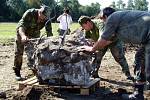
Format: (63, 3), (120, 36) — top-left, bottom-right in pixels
(122, 85), (144, 100)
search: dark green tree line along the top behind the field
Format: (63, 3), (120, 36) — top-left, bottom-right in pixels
(0, 0), (148, 22)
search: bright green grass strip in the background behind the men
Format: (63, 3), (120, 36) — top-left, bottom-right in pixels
(0, 23), (79, 43)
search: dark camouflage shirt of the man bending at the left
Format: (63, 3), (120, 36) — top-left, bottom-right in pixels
(17, 8), (51, 38)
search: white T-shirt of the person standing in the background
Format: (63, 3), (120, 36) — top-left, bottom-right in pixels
(57, 14), (72, 30)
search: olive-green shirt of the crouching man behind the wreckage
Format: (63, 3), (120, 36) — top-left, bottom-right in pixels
(85, 19), (104, 41)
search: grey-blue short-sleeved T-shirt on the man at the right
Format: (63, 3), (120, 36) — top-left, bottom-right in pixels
(101, 11), (150, 44)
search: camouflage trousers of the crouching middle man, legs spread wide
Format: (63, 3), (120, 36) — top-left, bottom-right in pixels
(93, 40), (130, 74)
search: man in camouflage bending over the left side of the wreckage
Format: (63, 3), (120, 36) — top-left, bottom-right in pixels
(13, 5), (53, 80)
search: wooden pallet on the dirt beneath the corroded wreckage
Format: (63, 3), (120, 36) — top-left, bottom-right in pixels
(19, 76), (100, 95)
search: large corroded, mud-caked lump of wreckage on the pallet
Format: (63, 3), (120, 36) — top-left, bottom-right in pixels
(25, 33), (95, 85)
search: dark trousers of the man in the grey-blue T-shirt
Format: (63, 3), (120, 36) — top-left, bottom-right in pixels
(135, 42), (150, 82)
